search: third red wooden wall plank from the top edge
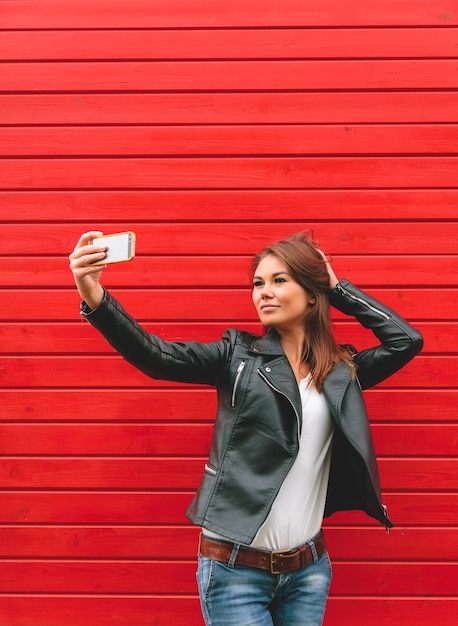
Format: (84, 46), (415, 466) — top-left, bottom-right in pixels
(0, 59), (458, 93)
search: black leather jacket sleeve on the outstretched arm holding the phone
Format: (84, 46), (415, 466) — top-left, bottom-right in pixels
(81, 291), (235, 385)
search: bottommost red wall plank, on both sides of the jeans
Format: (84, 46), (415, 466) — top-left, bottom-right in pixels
(0, 594), (458, 626)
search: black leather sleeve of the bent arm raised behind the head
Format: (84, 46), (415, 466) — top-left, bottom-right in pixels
(329, 279), (423, 389)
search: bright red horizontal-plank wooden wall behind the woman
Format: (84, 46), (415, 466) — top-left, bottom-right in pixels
(0, 0), (458, 626)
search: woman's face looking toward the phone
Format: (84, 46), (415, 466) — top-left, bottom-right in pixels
(252, 254), (315, 331)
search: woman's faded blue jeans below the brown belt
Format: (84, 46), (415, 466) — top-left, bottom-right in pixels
(197, 536), (332, 626)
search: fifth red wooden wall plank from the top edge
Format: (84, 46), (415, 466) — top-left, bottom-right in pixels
(0, 122), (458, 157)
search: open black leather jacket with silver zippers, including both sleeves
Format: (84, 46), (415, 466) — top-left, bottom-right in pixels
(82, 280), (423, 544)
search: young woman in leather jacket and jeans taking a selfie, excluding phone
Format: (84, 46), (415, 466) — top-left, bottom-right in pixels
(70, 232), (422, 626)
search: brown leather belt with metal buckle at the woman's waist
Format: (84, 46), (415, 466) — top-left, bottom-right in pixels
(199, 533), (326, 574)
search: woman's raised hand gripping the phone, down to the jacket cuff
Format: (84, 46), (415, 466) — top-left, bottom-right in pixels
(68, 230), (106, 309)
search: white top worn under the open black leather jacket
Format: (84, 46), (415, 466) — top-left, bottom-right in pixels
(205, 374), (334, 550)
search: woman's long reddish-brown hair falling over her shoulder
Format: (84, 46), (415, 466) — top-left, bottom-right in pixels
(252, 232), (354, 391)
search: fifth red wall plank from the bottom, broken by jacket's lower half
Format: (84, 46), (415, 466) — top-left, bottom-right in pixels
(0, 456), (458, 490)
